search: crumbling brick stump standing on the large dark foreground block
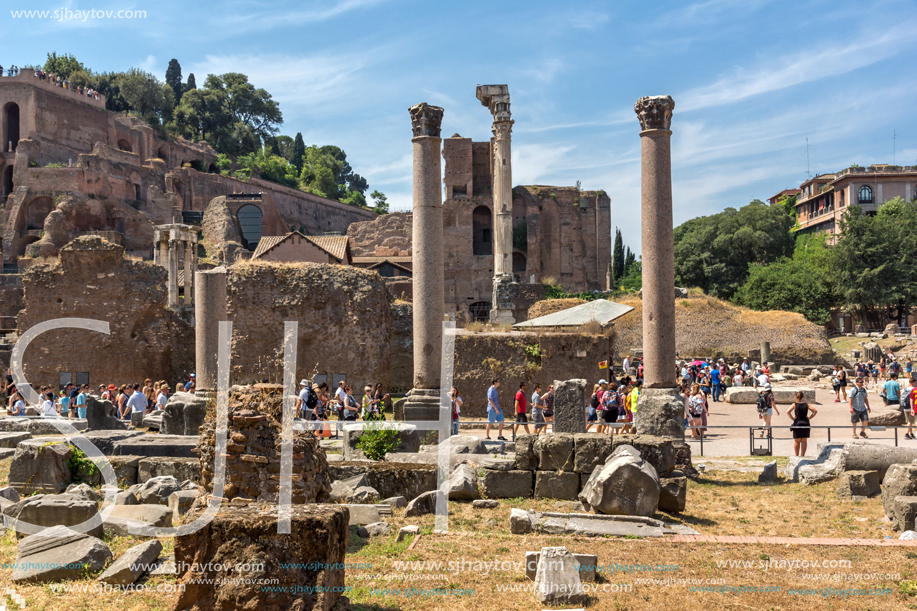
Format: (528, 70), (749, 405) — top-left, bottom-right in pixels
(198, 384), (331, 504)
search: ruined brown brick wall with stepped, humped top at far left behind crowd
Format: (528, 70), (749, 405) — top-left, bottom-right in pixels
(18, 236), (194, 387)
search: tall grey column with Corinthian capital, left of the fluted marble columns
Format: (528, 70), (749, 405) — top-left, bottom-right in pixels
(404, 103), (445, 420)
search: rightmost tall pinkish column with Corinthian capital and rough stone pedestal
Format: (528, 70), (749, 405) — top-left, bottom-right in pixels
(634, 95), (684, 438)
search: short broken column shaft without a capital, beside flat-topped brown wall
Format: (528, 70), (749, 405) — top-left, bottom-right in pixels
(194, 266), (227, 394)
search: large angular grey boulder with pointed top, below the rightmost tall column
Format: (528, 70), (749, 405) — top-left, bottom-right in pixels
(579, 446), (659, 517)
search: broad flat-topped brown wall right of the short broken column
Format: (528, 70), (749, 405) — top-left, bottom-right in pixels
(227, 260), (394, 392)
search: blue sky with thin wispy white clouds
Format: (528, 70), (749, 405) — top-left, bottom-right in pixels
(0, 0), (917, 250)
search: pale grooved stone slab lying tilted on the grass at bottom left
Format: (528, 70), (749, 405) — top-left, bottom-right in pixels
(11, 526), (111, 583)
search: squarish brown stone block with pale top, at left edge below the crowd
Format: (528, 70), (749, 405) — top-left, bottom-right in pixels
(9, 437), (73, 495)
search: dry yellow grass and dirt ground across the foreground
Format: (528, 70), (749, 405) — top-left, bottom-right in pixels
(0, 457), (917, 611)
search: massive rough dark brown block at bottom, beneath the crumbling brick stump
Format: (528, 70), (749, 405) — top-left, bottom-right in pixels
(171, 503), (350, 611)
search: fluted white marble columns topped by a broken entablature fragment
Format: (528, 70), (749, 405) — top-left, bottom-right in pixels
(476, 85), (515, 324)
